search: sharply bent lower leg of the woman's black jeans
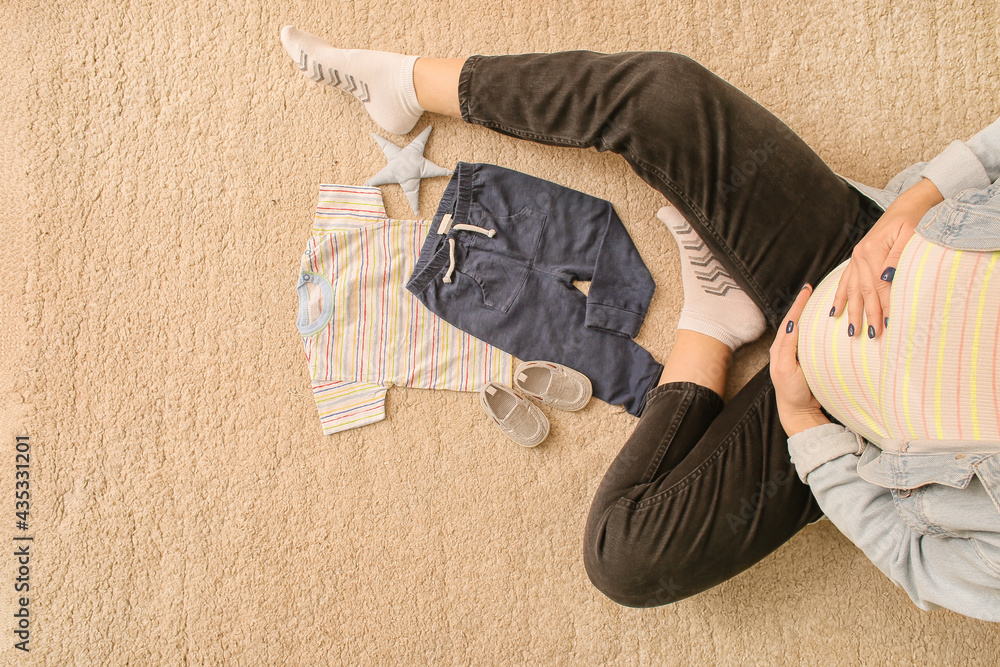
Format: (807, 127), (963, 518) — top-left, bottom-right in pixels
(583, 368), (822, 607)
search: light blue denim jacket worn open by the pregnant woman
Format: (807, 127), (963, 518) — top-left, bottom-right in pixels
(788, 120), (1000, 621)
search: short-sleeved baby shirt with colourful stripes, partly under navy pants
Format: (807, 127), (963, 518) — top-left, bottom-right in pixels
(296, 185), (512, 434)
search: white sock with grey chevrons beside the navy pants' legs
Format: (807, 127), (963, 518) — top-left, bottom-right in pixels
(656, 206), (767, 351)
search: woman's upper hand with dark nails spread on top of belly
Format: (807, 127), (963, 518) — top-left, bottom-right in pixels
(830, 178), (944, 338)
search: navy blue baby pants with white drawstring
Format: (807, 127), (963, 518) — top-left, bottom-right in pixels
(406, 162), (663, 415)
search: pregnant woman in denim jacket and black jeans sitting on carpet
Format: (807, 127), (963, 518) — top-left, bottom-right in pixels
(281, 26), (1000, 621)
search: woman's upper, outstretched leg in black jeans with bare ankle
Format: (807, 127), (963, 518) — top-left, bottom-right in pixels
(413, 51), (875, 326)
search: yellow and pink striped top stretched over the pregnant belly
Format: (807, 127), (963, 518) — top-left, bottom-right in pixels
(799, 234), (1000, 444)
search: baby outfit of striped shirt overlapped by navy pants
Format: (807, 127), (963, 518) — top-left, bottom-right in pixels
(296, 162), (663, 434)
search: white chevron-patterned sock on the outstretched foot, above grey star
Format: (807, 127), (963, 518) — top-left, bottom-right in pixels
(281, 25), (424, 134)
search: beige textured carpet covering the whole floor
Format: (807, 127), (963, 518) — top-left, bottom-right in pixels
(0, 0), (1000, 665)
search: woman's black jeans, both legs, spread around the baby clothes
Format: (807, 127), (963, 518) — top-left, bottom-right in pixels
(446, 51), (882, 607)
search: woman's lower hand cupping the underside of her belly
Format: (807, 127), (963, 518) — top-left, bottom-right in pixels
(771, 285), (830, 437)
